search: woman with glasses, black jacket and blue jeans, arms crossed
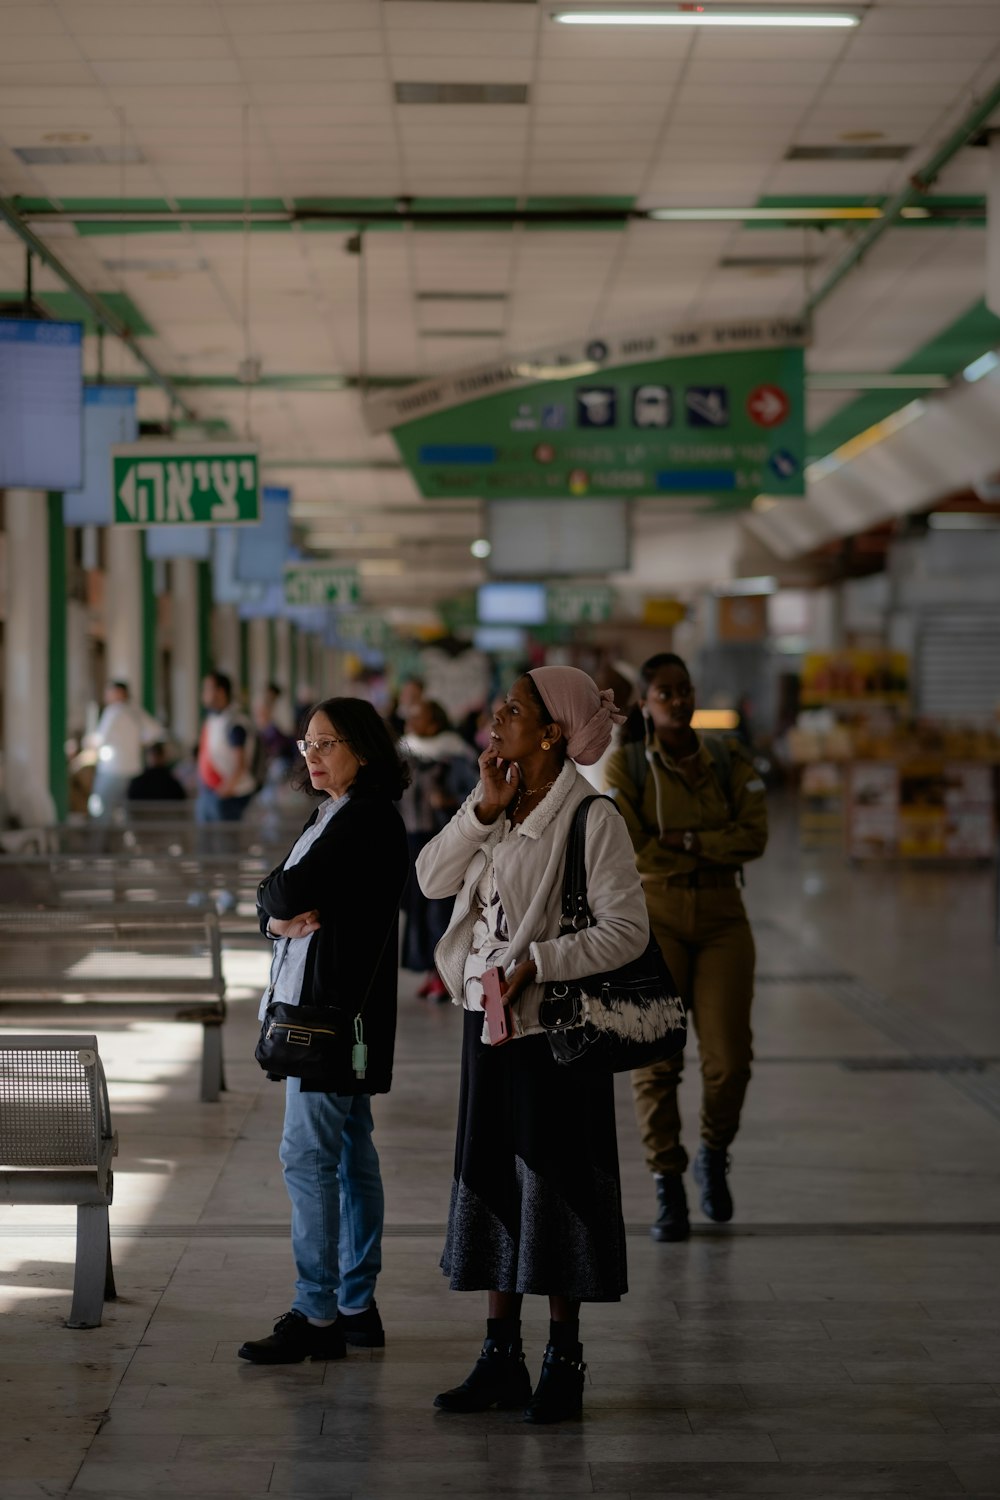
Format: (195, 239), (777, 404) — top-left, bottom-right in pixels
(240, 698), (409, 1365)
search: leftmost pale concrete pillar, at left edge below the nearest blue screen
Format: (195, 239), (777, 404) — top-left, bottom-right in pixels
(3, 489), (58, 828)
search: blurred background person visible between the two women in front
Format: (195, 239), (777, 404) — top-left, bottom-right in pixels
(400, 698), (478, 1002)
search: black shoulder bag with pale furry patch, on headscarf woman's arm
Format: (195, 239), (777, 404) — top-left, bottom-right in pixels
(538, 797), (687, 1073)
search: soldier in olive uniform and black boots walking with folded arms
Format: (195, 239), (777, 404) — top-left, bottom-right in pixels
(604, 653), (768, 1241)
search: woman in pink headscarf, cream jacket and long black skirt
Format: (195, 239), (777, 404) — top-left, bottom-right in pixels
(417, 666), (649, 1422)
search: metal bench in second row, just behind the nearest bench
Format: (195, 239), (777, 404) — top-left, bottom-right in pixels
(0, 905), (226, 1103)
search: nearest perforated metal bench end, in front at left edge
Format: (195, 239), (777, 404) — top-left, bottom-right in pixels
(0, 1035), (118, 1328)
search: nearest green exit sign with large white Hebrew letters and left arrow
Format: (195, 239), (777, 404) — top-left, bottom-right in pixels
(111, 443), (261, 527)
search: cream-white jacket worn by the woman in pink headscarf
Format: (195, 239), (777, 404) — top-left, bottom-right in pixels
(417, 761), (649, 1037)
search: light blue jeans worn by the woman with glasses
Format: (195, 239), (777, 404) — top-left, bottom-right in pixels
(279, 1079), (385, 1319)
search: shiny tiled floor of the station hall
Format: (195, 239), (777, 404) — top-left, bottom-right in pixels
(0, 831), (1000, 1500)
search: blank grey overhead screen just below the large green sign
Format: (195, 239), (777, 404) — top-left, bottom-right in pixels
(486, 500), (630, 578)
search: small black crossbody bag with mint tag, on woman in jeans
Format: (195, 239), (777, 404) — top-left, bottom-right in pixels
(253, 897), (402, 1083)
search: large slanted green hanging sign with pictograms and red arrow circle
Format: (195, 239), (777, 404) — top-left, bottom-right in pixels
(366, 318), (805, 509)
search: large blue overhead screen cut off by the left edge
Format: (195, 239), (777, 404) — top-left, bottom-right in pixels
(0, 318), (84, 491)
